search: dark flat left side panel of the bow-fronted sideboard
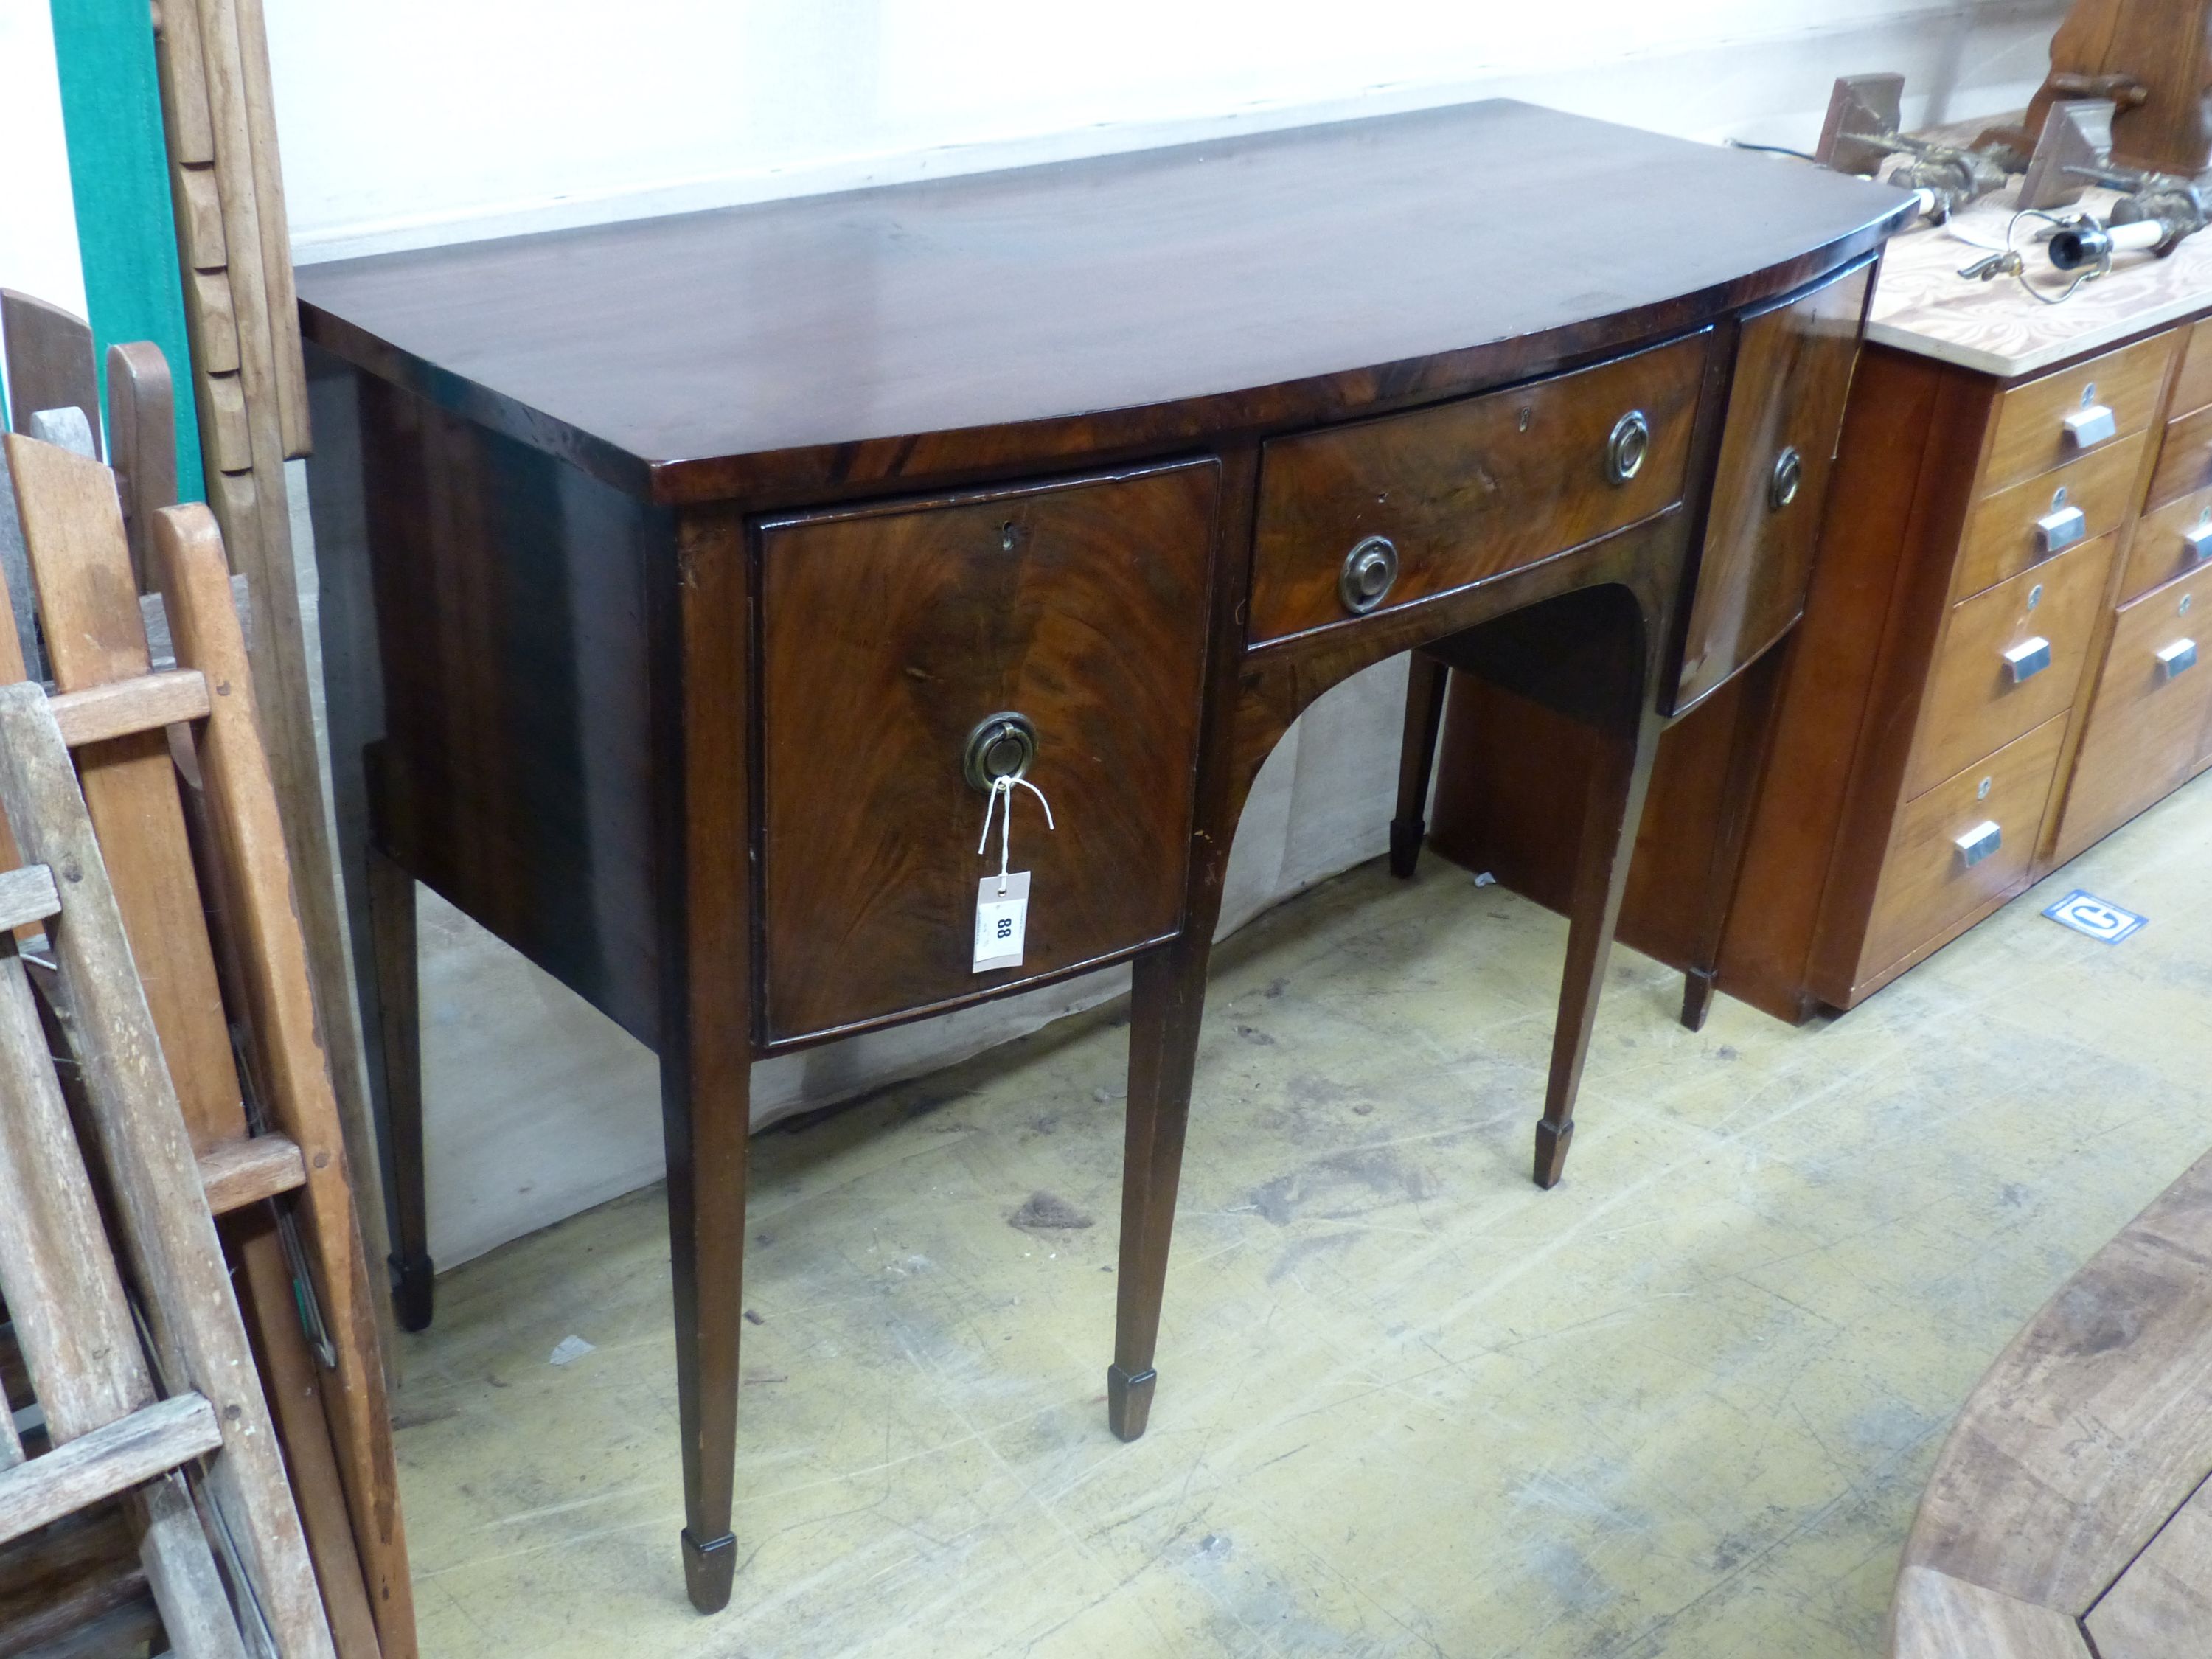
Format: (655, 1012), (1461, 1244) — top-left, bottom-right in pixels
(347, 376), (675, 1044)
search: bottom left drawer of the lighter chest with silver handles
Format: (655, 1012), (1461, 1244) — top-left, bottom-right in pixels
(1856, 714), (2068, 984)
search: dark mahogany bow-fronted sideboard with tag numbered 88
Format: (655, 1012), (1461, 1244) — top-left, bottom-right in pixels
(299, 102), (1909, 1610)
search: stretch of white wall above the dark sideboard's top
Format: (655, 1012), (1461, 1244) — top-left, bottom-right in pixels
(268, 0), (2064, 261)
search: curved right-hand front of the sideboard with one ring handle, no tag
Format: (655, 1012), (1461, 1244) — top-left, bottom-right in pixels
(1674, 265), (1874, 710)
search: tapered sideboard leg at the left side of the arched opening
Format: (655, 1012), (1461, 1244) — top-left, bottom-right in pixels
(1106, 929), (1212, 1440)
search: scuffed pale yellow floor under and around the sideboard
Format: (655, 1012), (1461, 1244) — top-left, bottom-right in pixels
(398, 783), (2212, 1659)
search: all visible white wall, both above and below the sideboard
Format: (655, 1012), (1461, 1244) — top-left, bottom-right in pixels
(26, 0), (2066, 1265)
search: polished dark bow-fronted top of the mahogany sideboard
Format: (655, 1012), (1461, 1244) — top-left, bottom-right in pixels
(299, 100), (1902, 504)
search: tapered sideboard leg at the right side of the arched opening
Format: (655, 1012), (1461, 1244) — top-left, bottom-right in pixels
(1535, 714), (1663, 1188)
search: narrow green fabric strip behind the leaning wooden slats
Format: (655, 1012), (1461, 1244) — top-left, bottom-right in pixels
(53, 0), (206, 500)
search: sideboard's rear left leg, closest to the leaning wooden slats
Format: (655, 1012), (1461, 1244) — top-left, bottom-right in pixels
(369, 845), (436, 1332)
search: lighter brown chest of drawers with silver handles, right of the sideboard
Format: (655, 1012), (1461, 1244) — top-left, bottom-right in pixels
(1436, 188), (2212, 1024)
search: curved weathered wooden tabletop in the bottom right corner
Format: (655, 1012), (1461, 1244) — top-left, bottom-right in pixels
(1893, 1157), (2212, 1659)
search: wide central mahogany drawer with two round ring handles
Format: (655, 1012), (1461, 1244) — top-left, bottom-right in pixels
(1248, 334), (1710, 644)
